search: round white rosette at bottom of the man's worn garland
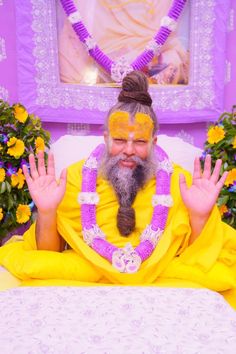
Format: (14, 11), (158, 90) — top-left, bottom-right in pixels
(112, 243), (142, 273)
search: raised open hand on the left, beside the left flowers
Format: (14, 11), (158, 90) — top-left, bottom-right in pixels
(23, 151), (67, 214)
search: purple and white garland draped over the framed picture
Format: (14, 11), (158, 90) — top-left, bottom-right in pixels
(61, 0), (186, 83)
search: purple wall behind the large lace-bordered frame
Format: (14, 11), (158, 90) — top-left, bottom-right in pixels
(0, 0), (236, 147)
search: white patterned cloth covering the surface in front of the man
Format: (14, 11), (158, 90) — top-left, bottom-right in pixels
(0, 286), (236, 354)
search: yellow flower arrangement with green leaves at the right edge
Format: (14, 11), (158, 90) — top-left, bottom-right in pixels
(201, 105), (236, 228)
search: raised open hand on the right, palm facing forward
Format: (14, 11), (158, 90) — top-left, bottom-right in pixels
(180, 155), (227, 218)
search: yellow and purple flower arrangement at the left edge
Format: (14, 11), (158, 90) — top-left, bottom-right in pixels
(0, 100), (50, 241)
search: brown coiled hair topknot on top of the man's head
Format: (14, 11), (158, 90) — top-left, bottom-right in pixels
(118, 71), (152, 106)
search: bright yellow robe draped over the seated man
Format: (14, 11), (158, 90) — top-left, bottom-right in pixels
(0, 161), (236, 308)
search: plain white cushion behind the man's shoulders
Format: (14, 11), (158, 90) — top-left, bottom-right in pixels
(51, 134), (202, 176)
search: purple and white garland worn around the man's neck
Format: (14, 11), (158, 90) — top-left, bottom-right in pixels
(78, 144), (172, 273)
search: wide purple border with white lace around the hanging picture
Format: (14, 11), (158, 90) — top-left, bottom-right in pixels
(15, 0), (230, 124)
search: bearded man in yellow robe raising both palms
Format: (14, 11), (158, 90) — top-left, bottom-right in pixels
(0, 71), (236, 306)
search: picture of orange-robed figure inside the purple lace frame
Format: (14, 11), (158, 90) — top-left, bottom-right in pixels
(58, 0), (190, 85)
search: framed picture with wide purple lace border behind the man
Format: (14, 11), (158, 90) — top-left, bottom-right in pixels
(15, 0), (230, 124)
